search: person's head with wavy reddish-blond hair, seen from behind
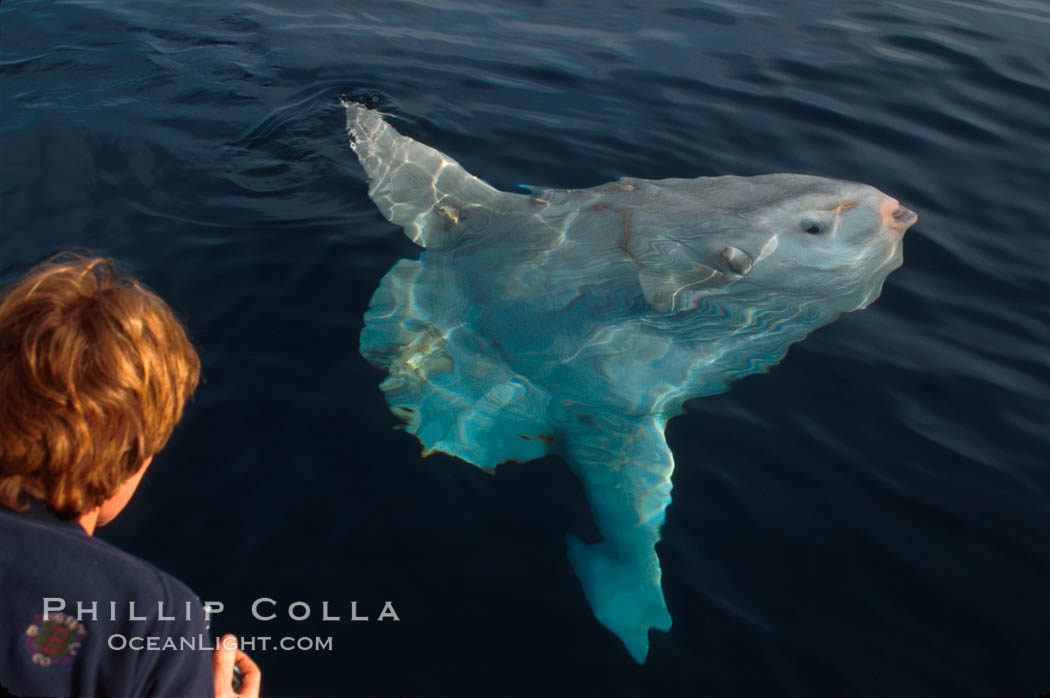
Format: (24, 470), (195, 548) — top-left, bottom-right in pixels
(0, 254), (201, 523)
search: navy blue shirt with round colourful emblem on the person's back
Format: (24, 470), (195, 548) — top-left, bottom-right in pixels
(0, 502), (213, 698)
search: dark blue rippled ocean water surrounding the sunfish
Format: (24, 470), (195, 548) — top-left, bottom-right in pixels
(0, 0), (1050, 697)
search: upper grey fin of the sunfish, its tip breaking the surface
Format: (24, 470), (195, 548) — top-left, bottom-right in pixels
(341, 100), (515, 250)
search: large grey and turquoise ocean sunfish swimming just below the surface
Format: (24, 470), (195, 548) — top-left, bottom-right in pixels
(342, 100), (918, 663)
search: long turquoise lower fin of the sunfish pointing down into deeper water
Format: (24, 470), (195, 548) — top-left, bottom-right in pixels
(561, 416), (674, 663)
